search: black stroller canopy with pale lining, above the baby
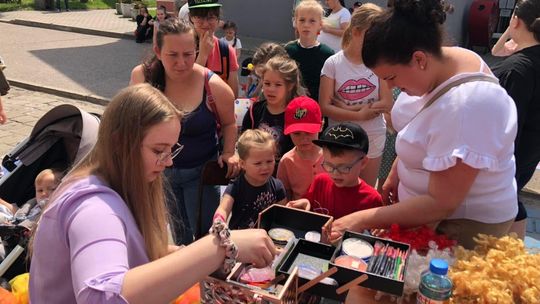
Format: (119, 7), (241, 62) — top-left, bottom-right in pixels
(0, 104), (99, 205)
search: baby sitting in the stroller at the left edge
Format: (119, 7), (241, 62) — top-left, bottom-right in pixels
(0, 169), (62, 229)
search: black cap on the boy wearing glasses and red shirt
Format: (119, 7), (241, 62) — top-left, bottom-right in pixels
(313, 122), (369, 154)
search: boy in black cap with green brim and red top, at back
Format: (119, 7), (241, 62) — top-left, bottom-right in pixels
(188, 0), (239, 97)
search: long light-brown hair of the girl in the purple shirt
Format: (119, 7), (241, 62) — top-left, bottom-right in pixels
(48, 83), (182, 260)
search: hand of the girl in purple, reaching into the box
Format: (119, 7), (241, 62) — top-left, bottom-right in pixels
(231, 229), (277, 268)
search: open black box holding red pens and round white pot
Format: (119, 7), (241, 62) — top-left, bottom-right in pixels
(331, 231), (410, 296)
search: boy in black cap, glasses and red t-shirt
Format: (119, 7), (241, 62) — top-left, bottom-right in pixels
(288, 122), (382, 219)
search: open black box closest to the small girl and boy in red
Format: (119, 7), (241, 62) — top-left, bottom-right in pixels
(259, 205), (333, 241)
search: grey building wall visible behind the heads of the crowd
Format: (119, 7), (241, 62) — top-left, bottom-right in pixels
(222, 0), (473, 45)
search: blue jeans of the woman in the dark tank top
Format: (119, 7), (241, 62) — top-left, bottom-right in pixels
(165, 165), (219, 245)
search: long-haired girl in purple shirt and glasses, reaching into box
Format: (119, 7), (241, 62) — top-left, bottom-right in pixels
(30, 84), (275, 304)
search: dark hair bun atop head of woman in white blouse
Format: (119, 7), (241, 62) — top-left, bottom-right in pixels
(394, 0), (447, 25)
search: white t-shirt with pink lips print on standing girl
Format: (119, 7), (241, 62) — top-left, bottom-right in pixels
(321, 51), (386, 136)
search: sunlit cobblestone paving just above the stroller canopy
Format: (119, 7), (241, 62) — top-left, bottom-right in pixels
(0, 87), (104, 157)
